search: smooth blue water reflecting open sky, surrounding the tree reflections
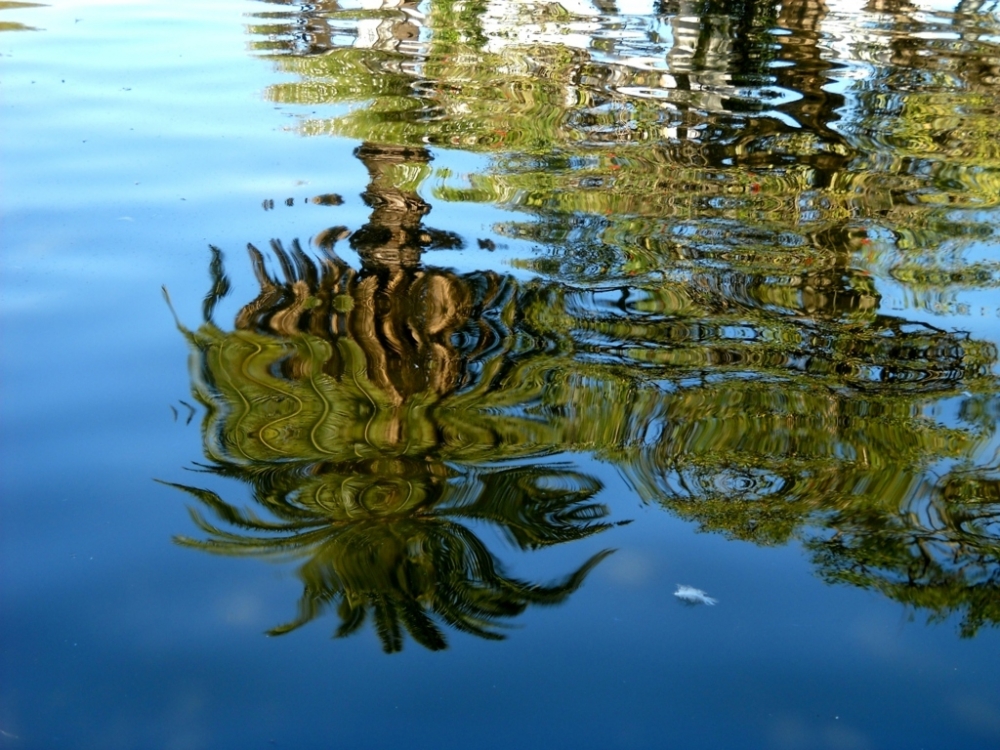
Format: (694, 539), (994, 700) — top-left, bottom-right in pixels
(0, 2), (1000, 750)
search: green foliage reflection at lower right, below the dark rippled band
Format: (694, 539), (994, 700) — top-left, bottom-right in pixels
(626, 384), (1000, 636)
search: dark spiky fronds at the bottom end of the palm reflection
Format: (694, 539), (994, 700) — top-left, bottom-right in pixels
(173, 461), (608, 652)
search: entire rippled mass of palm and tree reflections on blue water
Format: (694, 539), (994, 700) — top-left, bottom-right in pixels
(164, 0), (1000, 651)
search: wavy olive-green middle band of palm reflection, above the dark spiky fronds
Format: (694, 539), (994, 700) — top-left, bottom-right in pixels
(183, 283), (572, 463)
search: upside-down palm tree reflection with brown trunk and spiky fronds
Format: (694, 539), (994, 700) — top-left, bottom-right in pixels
(173, 144), (609, 652)
